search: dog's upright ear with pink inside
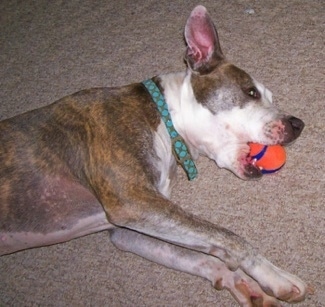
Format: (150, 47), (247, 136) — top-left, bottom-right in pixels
(185, 5), (224, 74)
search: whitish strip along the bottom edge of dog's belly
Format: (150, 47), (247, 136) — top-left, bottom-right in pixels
(0, 210), (113, 255)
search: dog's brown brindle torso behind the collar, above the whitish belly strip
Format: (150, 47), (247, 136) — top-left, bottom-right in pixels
(0, 84), (160, 234)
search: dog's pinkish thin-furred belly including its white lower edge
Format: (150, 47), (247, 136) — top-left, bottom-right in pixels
(0, 175), (112, 255)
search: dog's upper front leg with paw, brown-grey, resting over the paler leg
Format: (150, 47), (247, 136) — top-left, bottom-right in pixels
(98, 188), (307, 302)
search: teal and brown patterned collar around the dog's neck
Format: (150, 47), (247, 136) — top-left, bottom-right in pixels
(142, 79), (198, 180)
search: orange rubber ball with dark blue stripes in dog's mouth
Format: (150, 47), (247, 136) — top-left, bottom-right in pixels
(248, 143), (286, 174)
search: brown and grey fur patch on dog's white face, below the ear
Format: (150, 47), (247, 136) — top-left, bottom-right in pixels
(191, 63), (256, 113)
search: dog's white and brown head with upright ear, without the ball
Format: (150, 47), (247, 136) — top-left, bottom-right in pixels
(177, 6), (304, 179)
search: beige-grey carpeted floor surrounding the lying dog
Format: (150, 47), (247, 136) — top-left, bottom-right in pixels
(0, 0), (325, 307)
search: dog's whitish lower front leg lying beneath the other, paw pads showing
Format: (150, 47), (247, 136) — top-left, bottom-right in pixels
(111, 228), (280, 306)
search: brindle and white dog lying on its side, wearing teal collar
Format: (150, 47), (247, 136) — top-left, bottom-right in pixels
(0, 6), (311, 306)
